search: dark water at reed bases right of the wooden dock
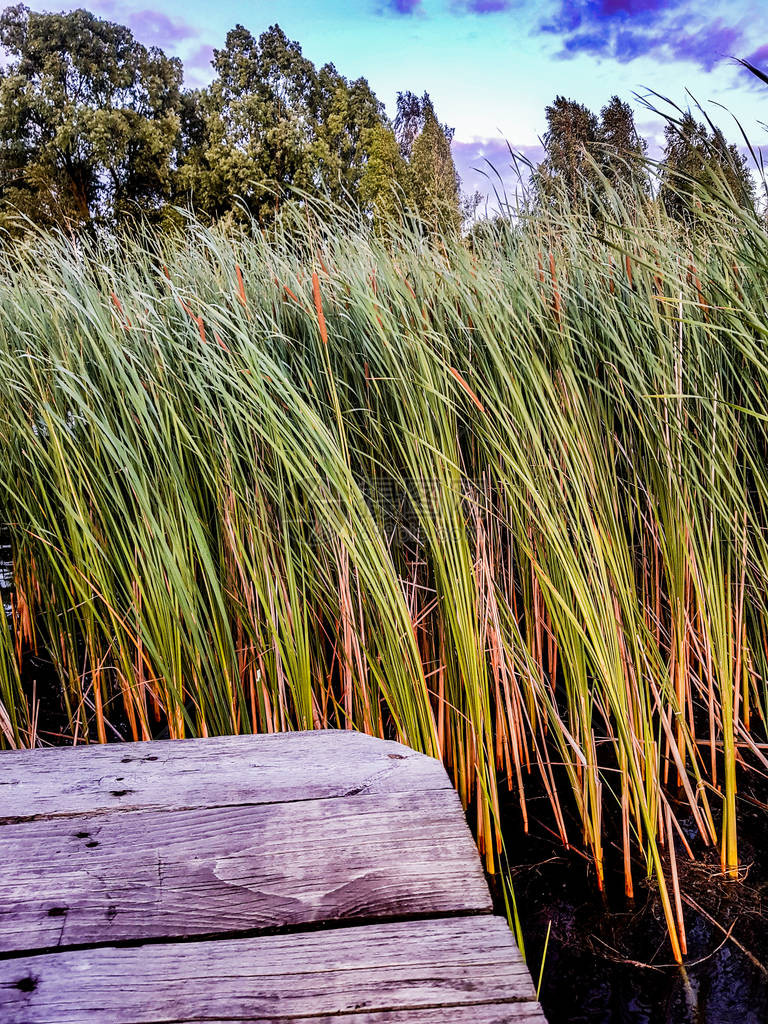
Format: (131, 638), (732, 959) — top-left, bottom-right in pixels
(507, 784), (768, 1024)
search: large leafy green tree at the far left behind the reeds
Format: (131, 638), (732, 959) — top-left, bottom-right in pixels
(0, 4), (181, 227)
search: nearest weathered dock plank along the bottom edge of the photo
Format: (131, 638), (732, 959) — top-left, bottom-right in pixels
(0, 915), (543, 1024)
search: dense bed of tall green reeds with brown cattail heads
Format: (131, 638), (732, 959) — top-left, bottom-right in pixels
(0, 188), (768, 959)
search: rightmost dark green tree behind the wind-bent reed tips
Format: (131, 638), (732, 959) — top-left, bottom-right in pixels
(659, 112), (755, 221)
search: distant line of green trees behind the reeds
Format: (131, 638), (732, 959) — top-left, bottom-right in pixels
(0, 4), (755, 232)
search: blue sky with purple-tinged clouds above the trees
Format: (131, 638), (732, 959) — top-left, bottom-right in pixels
(28, 0), (768, 203)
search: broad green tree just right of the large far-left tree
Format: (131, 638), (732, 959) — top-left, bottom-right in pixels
(177, 25), (383, 218)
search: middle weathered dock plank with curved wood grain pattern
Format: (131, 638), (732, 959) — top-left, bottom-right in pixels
(0, 790), (492, 952)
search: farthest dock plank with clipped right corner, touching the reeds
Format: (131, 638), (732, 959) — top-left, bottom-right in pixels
(0, 730), (450, 822)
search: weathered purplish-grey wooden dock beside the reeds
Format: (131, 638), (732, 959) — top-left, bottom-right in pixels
(0, 732), (545, 1024)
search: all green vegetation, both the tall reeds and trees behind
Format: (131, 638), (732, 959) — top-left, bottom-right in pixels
(0, 5), (768, 983)
